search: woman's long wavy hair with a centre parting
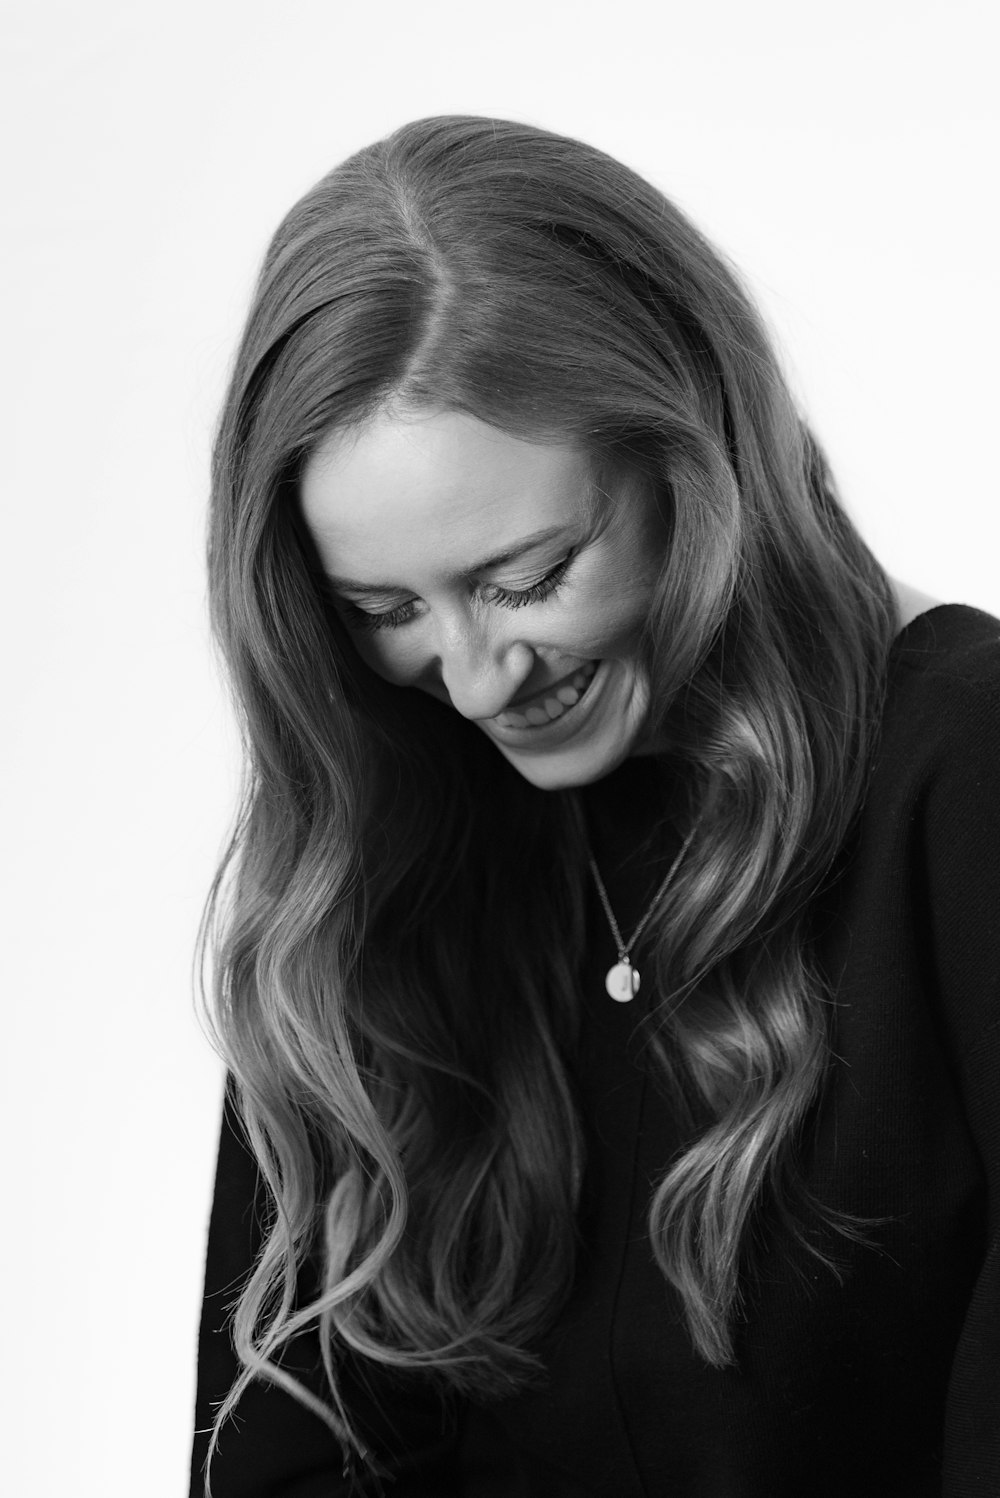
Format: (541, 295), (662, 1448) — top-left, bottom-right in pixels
(199, 117), (894, 1471)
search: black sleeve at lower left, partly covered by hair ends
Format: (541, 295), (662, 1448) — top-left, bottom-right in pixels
(190, 1085), (458, 1498)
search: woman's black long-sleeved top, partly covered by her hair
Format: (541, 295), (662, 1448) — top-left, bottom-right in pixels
(190, 605), (1000, 1498)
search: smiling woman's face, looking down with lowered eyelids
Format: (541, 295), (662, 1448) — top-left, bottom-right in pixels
(301, 409), (665, 789)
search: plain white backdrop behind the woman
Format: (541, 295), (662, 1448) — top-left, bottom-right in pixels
(0, 0), (1000, 1498)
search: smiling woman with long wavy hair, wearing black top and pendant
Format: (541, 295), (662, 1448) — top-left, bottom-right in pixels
(192, 117), (1000, 1498)
